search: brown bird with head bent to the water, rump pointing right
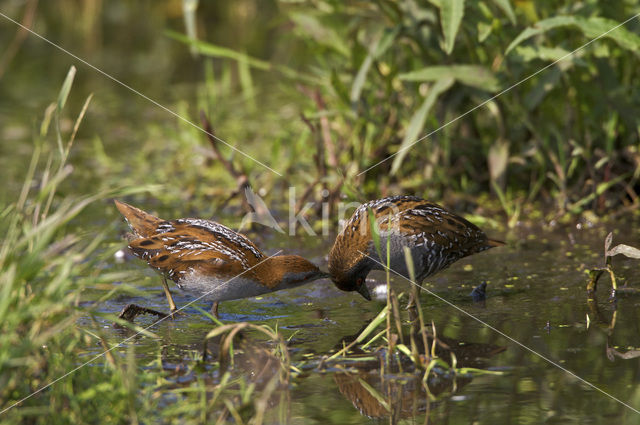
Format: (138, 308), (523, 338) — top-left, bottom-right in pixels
(329, 196), (504, 300)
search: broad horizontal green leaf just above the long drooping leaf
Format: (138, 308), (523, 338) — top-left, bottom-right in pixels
(398, 65), (500, 92)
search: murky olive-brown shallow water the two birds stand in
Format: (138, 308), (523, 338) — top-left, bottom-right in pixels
(85, 220), (640, 424)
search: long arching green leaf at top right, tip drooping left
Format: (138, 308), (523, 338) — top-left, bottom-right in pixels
(505, 16), (640, 55)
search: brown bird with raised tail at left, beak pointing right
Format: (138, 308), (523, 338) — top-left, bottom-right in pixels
(115, 200), (329, 317)
